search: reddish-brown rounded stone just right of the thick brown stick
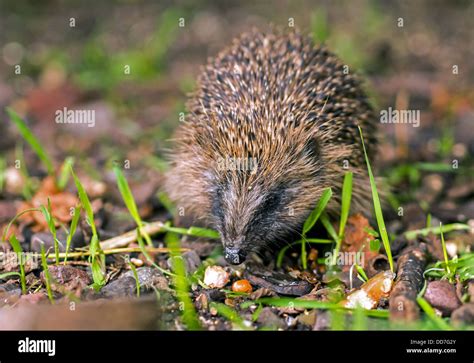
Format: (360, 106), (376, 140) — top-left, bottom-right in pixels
(424, 281), (461, 316)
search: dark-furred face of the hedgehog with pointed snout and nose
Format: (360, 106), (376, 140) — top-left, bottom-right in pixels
(210, 162), (313, 264)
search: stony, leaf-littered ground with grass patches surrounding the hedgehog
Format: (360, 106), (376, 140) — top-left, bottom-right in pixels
(0, 0), (474, 330)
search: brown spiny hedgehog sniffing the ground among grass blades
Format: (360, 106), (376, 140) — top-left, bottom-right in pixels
(165, 29), (376, 264)
